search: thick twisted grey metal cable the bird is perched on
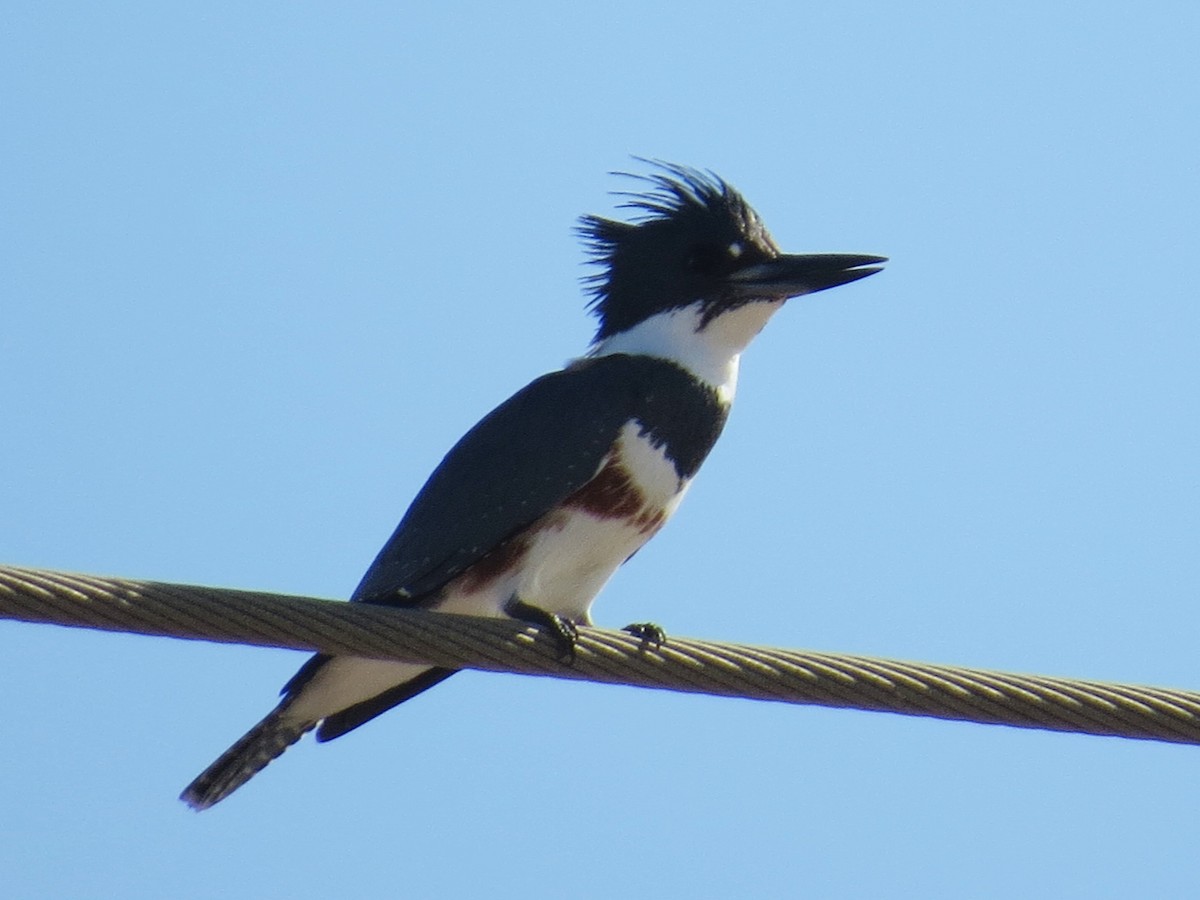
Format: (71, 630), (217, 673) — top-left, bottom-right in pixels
(0, 566), (1200, 744)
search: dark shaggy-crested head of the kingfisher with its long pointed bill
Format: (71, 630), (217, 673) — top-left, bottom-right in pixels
(580, 162), (886, 343)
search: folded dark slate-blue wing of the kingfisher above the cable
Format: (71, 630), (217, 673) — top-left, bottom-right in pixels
(352, 356), (657, 606)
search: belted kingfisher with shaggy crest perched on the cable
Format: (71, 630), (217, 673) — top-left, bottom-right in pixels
(181, 162), (887, 810)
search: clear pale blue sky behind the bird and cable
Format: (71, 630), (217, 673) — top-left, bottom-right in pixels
(0, 2), (1200, 898)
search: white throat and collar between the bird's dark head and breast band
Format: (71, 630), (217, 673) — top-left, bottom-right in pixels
(588, 300), (784, 403)
